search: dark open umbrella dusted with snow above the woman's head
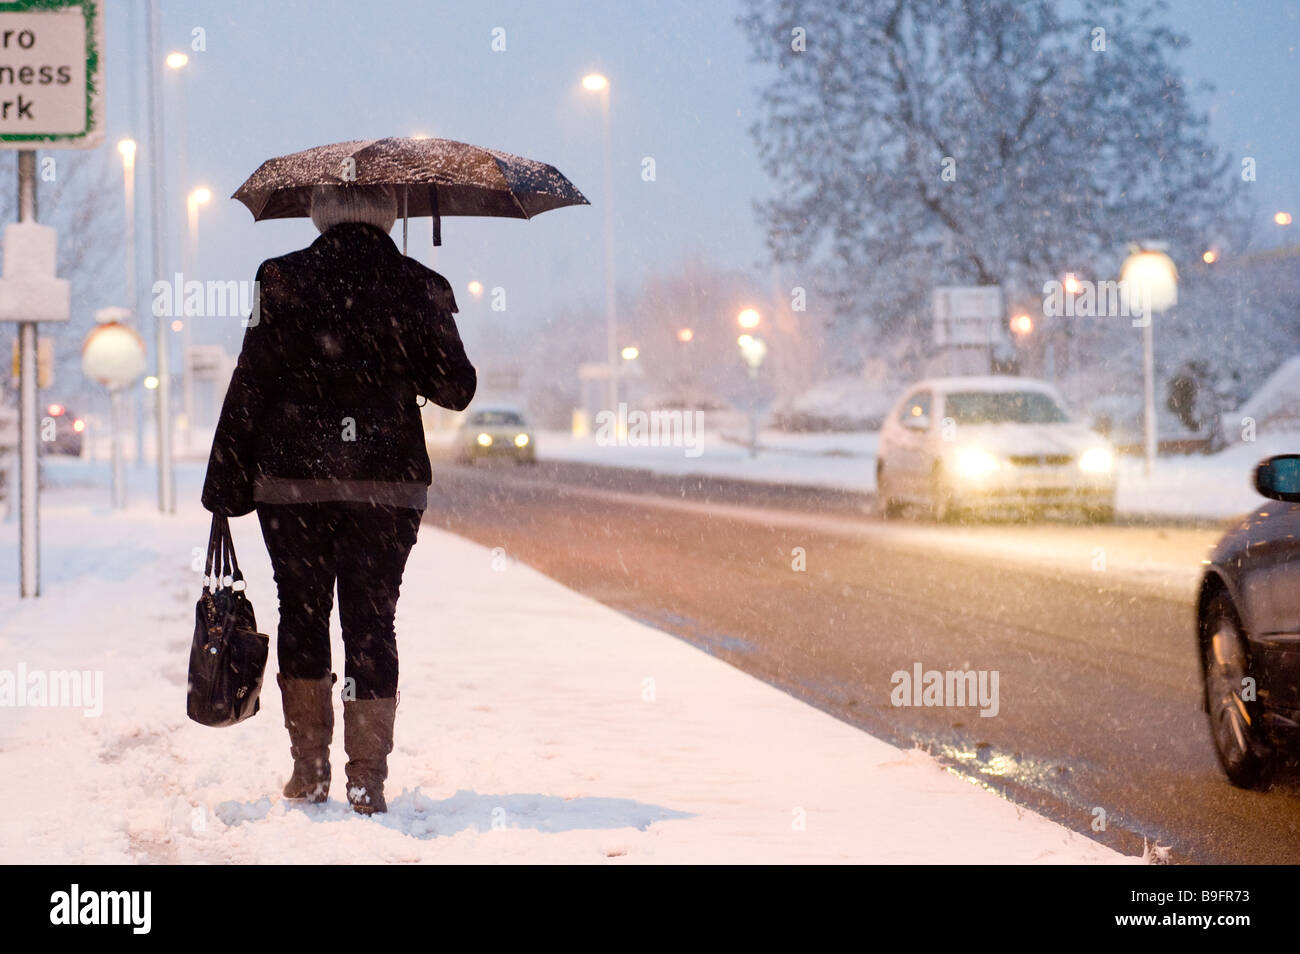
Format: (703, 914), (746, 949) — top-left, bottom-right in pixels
(231, 138), (590, 244)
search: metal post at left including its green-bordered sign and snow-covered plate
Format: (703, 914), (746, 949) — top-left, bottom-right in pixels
(0, 0), (104, 597)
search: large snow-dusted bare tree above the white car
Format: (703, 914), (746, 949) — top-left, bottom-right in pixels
(741, 0), (1236, 356)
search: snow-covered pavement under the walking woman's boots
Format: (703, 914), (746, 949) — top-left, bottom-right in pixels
(0, 461), (1138, 863)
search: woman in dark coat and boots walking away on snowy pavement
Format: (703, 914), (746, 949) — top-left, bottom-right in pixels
(203, 186), (477, 815)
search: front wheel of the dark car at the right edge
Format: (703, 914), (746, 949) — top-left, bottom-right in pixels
(1201, 593), (1273, 789)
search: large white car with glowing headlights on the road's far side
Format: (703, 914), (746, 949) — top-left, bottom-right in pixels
(876, 376), (1115, 522)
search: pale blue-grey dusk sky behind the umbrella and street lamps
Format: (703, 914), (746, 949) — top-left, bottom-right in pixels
(98, 0), (1300, 356)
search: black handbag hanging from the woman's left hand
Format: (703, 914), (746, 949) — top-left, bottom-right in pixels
(186, 516), (270, 725)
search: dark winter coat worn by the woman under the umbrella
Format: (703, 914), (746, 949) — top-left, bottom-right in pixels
(203, 224), (477, 516)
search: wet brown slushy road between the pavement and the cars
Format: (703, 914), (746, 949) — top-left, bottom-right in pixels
(426, 460), (1300, 863)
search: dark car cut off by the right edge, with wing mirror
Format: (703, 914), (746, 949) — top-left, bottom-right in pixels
(1196, 454), (1300, 788)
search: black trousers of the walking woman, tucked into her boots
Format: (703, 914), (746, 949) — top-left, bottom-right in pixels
(257, 502), (424, 699)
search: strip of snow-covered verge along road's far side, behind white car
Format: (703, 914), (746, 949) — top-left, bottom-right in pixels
(525, 430), (1300, 520)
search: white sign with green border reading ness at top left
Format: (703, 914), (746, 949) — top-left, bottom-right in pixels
(0, 0), (104, 149)
